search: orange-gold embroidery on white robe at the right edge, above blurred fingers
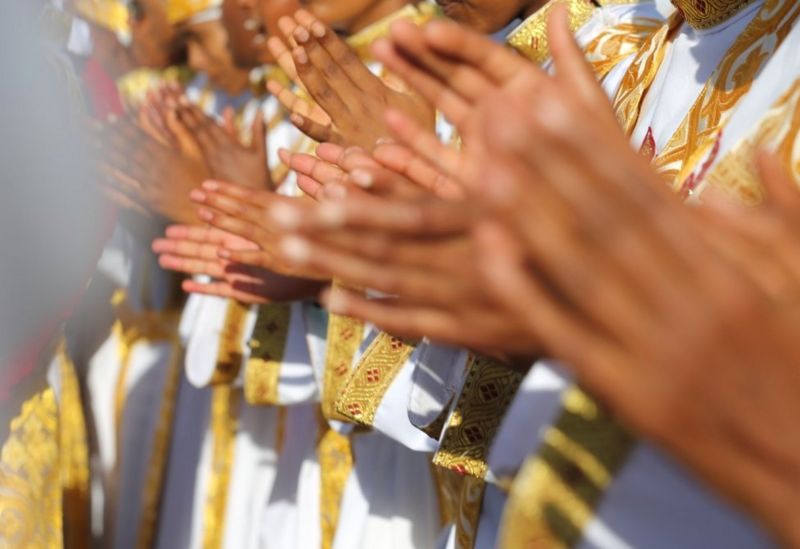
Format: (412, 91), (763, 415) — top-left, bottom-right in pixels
(704, 80), (800, 206)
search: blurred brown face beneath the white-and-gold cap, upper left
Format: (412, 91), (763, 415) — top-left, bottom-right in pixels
(187, 21), (248, 93)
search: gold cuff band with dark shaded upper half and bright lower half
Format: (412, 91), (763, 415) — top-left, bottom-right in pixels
(244, 304), (292, 405)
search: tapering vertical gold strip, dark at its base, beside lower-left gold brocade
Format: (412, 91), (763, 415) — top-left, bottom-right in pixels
(58, 346), (91, 548)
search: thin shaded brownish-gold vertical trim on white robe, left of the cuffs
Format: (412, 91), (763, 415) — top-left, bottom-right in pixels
(136, 332), (183, 549)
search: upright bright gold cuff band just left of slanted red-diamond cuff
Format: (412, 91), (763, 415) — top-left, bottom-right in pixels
(322, 314), (364, 421)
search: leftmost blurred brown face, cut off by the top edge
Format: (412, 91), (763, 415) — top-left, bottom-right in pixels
(130, 0), (186, 69)
